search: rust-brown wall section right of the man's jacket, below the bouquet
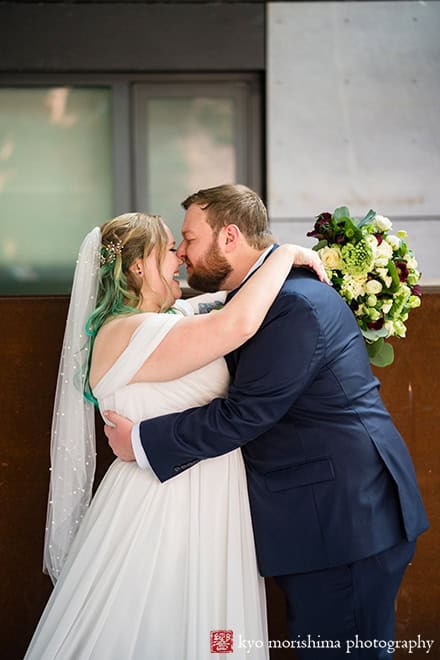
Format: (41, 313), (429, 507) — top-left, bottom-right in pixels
(375, 293), (440, 658)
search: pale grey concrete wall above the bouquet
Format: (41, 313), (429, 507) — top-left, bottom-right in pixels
(267, 1), (440, 284)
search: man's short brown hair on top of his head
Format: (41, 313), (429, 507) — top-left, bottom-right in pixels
(182, 184), (275, 250)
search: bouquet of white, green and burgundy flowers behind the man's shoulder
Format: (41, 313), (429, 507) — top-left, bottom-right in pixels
(307, 206), (421, 367)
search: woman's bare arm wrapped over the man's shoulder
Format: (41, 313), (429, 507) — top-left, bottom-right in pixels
(131, 244), (325, 382)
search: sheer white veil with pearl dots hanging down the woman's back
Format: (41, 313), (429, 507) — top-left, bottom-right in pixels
(43, 227), (101, 583)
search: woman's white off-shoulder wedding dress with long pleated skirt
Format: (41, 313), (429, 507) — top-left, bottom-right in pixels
(25, 314), (268, 660)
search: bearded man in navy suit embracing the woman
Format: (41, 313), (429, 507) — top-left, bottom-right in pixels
(106, 185), (428, 658)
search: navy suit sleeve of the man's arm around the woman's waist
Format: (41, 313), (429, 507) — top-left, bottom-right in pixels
(140, 294), (325, 481)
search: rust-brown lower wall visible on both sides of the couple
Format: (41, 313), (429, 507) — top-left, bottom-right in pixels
(0, 294), (440, 660)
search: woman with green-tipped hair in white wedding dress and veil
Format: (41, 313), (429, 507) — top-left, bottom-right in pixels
(25, 213), (322, 660)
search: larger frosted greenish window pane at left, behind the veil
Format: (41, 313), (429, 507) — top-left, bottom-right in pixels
(0, 87), (112, 294)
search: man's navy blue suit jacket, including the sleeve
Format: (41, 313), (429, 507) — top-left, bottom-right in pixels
(140, 268), (428, 575)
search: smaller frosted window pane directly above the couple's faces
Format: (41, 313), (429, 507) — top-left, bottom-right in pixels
(143, 96), (237, 237)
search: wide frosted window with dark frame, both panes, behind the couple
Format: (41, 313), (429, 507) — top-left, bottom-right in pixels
(0, 74), (261, 294)
